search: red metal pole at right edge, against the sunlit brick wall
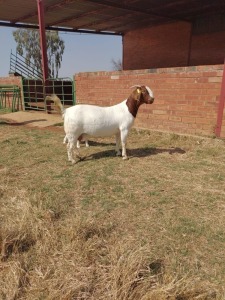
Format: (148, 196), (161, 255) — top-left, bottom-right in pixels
(215, 61), (225, 137)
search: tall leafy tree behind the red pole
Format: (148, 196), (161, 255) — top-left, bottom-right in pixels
(13, 29), (65, 78)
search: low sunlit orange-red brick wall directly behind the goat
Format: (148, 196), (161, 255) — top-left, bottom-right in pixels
(75, 65), (225, 137)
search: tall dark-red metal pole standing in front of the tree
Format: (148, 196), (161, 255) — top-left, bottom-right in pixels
(37, 0), (48, 82)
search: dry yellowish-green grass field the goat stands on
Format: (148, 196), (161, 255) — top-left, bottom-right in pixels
(0, 122), (225, 300)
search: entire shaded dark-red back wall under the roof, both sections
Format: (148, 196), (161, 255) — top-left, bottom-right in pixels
(123, 22), (225, 70)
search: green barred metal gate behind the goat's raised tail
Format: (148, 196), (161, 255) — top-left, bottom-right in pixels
(23, 78), (75, 113)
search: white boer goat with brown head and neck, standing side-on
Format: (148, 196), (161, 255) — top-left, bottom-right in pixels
(48, 86), (154, 163)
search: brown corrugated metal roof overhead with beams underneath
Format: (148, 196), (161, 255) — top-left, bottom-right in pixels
(0, 0), (225, 35)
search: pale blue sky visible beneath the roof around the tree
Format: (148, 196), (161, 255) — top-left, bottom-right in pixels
(0, 27), (122, 78)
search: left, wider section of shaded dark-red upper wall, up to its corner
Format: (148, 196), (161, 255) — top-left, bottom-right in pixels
(123, 22), (191, 70)
